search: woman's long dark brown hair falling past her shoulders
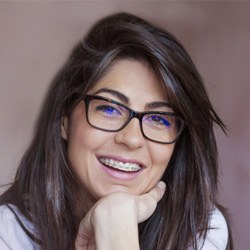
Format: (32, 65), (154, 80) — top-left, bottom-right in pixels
(0, 13), (233, 250)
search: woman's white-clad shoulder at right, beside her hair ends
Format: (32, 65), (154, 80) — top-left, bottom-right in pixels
(199, 208), (228, 250)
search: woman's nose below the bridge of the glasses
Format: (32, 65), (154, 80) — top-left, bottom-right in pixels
(115, 119), (144, 150)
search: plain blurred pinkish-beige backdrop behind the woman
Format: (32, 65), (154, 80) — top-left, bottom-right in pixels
(0, 0), (250, 250)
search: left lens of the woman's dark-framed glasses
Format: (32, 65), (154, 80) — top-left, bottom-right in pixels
(88, 99), (129, 131)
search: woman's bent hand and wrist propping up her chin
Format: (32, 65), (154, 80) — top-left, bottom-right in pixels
(75, 181), (165, 250)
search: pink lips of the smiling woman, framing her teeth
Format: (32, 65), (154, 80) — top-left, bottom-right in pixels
(97, 155), (146, 180)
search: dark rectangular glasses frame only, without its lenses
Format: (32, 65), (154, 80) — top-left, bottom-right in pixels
(83, 95), (185, 144)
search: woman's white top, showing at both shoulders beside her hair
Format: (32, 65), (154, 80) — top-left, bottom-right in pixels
(0, 205), (228, 250)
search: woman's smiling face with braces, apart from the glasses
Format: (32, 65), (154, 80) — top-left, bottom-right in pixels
(62, 59), (174, 199)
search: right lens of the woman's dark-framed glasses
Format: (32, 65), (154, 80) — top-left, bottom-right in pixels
(142, 113), (180, 143)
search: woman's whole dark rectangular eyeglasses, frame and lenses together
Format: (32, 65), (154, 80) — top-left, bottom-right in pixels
(84, 95), (185, 144)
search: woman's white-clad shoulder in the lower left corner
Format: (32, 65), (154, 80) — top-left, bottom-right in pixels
(0, 205), (39, 250)
